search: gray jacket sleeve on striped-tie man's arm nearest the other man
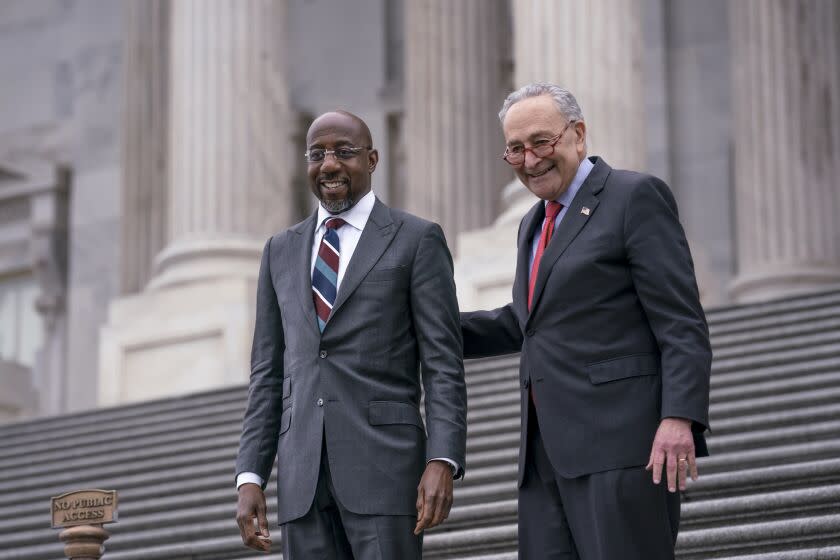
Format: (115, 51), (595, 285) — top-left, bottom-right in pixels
(410, 224), (467, 475)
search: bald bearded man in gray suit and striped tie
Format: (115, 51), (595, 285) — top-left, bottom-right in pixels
(236, 111), (466, 560)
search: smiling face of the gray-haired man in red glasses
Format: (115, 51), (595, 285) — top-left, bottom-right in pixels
(502, 95), (586, 200)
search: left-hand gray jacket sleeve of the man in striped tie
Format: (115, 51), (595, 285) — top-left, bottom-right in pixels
(236, 239), (285, 489)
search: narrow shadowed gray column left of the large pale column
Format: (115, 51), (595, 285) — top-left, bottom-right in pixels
(120, 0), (171, 294)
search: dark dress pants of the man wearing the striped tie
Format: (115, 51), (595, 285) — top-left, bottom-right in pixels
(281, 440), (423, 560)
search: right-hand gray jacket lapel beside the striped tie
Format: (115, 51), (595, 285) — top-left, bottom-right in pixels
(328, 198), (399, 325)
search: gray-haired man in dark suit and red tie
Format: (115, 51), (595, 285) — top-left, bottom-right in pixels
(461, 84), (711, 560)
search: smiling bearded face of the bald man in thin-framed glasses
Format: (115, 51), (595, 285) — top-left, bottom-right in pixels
(306, 112), (379, 214)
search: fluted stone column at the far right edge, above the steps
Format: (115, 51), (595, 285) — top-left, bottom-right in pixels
(729, 0), (840, 301)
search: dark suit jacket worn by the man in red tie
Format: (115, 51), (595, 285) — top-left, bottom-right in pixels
(461, 158), (712, 484)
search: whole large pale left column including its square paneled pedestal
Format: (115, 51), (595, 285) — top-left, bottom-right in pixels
(99, 0), (300, 404)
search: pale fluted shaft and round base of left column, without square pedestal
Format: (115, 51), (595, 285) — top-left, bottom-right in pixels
(152, 0), (297, 287)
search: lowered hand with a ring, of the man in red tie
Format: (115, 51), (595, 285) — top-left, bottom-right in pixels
(645, 418), (698, 492)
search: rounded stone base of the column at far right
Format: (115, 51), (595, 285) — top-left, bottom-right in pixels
(730, 264), (840, 303)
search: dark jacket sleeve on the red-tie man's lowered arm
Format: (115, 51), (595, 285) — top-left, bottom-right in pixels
(624, 177), (712, 431)
